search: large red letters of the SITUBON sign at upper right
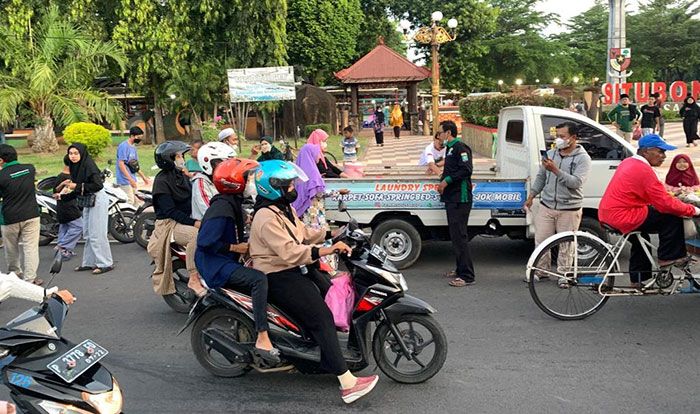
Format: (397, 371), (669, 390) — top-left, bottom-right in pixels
(601, 81), (700, 105)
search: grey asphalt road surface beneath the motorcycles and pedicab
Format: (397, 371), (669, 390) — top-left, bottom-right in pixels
(0, 238), (700, 413)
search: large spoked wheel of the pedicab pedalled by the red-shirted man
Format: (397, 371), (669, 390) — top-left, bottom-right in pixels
(528, 232), (618, 320)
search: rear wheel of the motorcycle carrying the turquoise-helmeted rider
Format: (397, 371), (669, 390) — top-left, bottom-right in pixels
(190, 308), (255, 378)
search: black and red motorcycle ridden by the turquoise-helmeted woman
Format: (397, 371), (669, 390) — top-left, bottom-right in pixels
(180, 202), (447, 384)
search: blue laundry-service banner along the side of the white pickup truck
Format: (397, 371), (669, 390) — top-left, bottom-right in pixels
(327, 180), (527, 210)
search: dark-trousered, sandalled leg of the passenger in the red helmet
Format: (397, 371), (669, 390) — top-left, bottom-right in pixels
(227, 267), (273, 351)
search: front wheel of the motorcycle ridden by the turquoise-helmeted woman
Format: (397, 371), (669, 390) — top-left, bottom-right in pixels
(372, 314), (447, 384)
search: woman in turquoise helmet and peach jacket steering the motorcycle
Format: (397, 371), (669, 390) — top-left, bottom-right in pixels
(249, 160), (379, 403)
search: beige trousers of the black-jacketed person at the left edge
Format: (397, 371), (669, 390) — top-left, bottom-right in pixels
(2, 217), (41, 282)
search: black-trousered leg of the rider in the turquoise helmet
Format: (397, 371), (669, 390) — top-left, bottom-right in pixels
(267, 270), (354, 376)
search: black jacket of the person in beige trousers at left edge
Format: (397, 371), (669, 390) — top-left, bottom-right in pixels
(0, 161), (39, 224)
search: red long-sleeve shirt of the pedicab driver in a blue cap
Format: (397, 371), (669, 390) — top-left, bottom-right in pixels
(598, 156), (695, 233)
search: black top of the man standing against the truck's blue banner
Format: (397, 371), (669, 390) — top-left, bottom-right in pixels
(440, 138), (474, 203)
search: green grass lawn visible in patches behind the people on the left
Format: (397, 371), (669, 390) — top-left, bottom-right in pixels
(12, 135), (369, 180)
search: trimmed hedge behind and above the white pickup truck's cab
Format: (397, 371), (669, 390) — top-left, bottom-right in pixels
(459, 95), (567, 128)
